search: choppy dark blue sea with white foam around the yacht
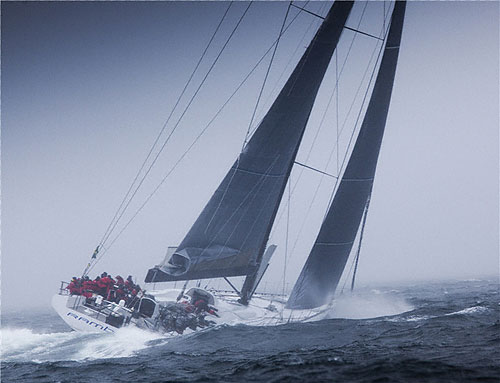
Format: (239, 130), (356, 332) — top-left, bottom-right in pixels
(1, 280), (500, 383)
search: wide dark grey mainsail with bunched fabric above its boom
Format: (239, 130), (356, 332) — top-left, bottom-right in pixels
(146, 1), (353, 286)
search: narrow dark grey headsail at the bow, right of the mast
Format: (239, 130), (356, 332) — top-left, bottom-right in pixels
(287, 1), (406, 309)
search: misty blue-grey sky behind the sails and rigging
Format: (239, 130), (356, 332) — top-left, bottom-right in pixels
(2, 2), (500, 308)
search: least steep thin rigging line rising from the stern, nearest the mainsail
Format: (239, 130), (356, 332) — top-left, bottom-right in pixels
(89, 3), (308, 271)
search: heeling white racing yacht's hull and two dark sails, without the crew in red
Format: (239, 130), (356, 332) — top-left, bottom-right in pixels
(53, 1), (406, 332)
